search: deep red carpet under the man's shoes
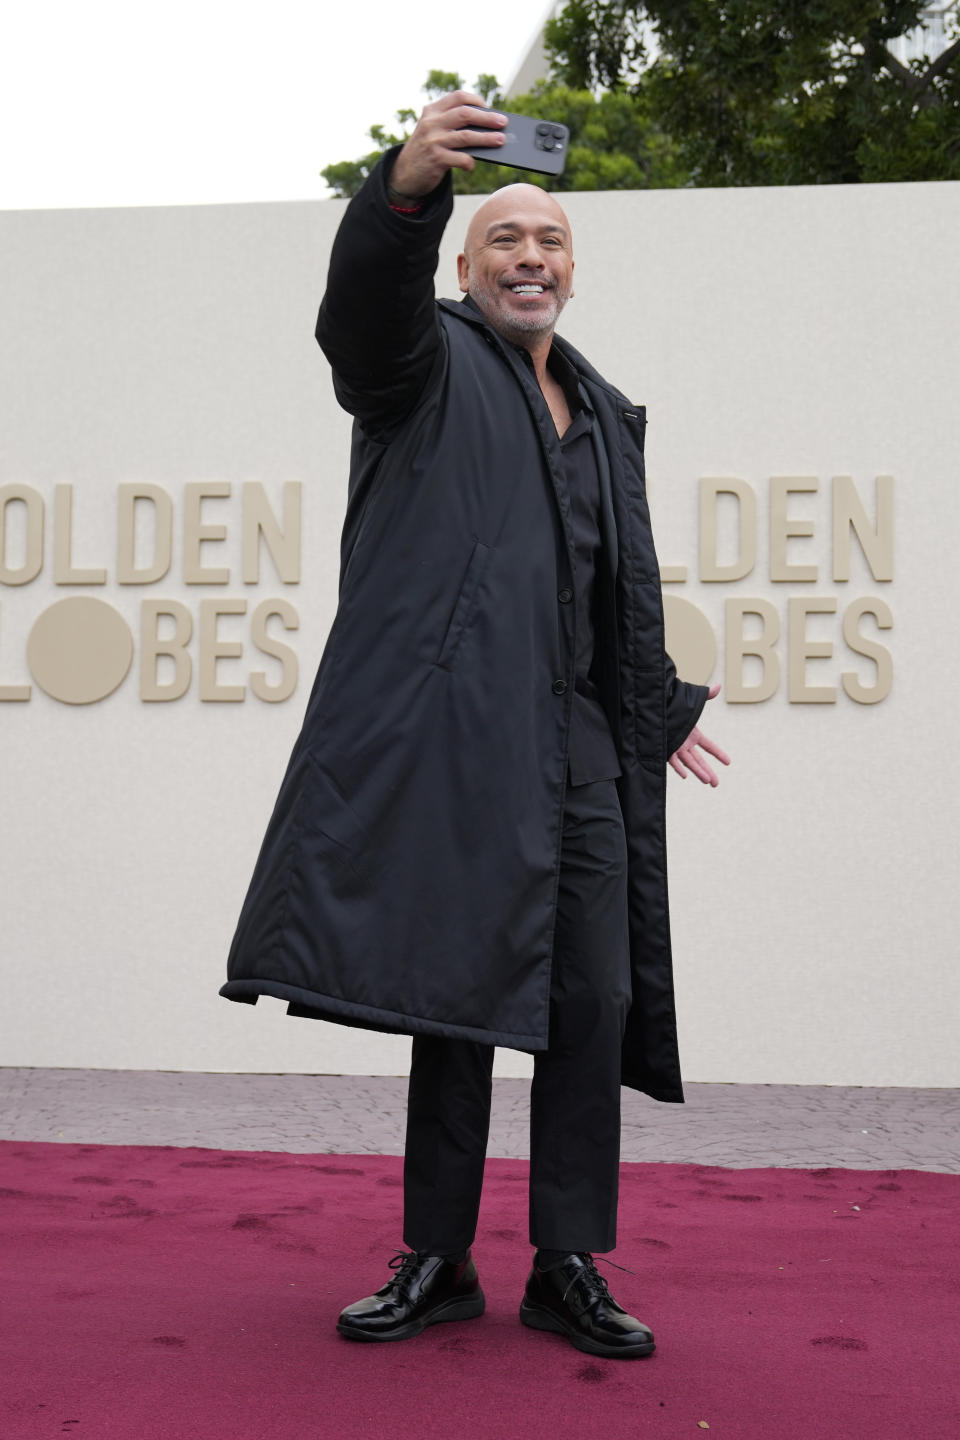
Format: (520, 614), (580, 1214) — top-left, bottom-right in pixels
(0, 1142), (960, 1440)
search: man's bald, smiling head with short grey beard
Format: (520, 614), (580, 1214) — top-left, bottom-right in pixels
(456, 184), (573, 346)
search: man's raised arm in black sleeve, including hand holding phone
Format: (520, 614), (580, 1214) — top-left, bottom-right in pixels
(317, 91), (507, 431)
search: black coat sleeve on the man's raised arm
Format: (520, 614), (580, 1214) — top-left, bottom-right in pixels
(317, 145), (453, 436)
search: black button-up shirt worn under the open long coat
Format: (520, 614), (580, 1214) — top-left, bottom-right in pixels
(522, 347), (620, 785)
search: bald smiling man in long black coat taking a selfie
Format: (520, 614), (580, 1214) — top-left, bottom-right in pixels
(223, 92), (727, 1358)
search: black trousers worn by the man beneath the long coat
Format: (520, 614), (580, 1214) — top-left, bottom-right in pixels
(403, 780), (630, 1254)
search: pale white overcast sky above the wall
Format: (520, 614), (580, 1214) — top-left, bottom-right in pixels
(0, 0), (547, 209)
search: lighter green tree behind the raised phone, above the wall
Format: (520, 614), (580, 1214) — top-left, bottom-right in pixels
(321, 71), (689, 197)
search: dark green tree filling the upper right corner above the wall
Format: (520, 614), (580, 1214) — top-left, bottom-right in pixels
(547, 0), (960, 186)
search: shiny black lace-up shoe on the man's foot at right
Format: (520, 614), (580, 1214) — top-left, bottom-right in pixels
(520, 1253), (656, 1359)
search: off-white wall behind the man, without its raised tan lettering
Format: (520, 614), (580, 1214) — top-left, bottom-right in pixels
(0, 183), (960, 1086)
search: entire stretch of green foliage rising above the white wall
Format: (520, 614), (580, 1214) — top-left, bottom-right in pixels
(322, 0), (960, 196)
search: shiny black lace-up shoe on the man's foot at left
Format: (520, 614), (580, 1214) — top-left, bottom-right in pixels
(337, 1250), (486, 1341)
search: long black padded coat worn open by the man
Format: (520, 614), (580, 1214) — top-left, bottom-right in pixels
(222, 161), (705, 1100)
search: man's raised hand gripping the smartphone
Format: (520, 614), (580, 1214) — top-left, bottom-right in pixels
(390, 91), (507, 200)
